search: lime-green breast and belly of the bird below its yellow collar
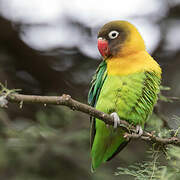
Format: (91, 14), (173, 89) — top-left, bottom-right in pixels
(96, 72), (159, 124)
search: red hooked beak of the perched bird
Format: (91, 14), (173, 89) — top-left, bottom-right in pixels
(98, 38), (110, 58)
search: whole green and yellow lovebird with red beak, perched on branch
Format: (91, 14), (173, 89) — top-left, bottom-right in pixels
(88, 20), (161, 171)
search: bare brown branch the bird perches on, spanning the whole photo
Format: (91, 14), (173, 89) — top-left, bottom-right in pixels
(0, 90), (180, 146)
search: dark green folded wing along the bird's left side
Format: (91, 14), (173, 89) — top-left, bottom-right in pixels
(88, 61), (107, 147)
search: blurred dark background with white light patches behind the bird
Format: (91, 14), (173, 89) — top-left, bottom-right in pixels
(0, 0), (180, 180)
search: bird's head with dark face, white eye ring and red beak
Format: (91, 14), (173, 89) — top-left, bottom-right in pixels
(98, 21), (144, 58)
